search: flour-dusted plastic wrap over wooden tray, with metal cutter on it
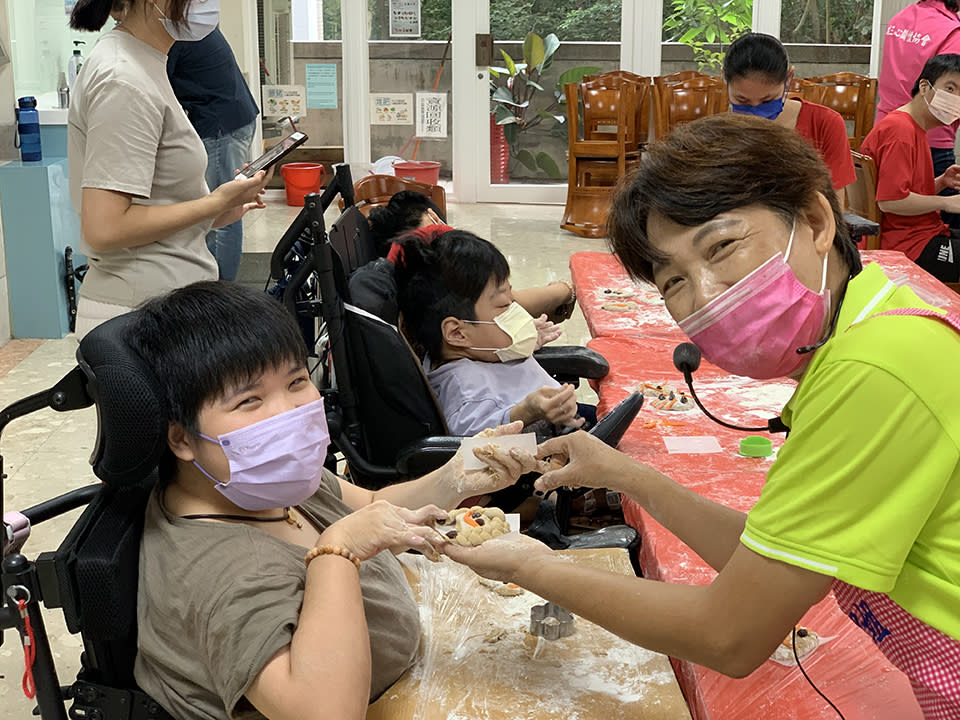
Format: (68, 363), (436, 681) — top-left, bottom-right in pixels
(367, 551), (690, 720)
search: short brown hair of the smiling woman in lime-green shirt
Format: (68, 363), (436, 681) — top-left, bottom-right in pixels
(607, 113), (862, 282)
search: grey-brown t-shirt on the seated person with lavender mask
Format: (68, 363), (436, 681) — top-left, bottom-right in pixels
(134, 471), (420, 720)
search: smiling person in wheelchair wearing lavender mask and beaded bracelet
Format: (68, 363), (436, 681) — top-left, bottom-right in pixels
(129, 282), (537, 718)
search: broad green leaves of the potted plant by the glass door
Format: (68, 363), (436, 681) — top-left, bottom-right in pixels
(490, 32), (600, 180)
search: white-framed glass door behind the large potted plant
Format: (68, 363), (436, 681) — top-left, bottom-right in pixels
(456, 0), (622, 203)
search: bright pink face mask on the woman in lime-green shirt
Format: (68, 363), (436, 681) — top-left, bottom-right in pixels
(679, 222), (830, 380)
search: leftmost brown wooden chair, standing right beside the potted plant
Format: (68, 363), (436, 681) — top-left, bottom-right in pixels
(560, 73), (650, 237)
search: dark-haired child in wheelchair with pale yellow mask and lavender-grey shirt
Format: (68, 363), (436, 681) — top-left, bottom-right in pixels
(396, 230), (596, 435)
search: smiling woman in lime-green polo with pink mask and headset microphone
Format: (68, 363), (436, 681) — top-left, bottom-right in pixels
(446, 114), (960, 720)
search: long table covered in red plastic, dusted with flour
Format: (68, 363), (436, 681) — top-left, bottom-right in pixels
(570, 251), (948, 720)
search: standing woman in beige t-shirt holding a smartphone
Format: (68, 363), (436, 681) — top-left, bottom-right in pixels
(68, 0), (268, 337)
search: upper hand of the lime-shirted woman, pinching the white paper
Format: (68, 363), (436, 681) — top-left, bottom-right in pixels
(534, 431), (636, 492)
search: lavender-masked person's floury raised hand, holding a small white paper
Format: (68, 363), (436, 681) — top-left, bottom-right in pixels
(441, 422), (542, 500)
